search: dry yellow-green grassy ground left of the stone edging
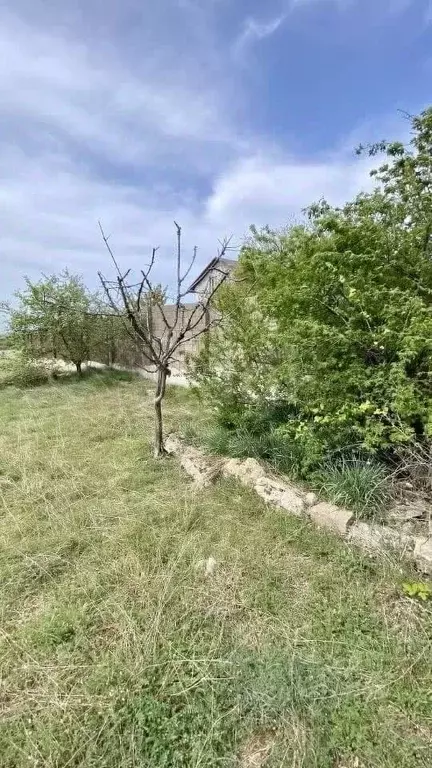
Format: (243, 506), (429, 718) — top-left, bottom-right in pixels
(0, 372), (432, 768)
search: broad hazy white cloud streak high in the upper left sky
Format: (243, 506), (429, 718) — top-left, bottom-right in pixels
(0, 12), (240, 172)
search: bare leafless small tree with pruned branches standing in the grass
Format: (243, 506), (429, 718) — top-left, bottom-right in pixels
(99, 222), (230, 458)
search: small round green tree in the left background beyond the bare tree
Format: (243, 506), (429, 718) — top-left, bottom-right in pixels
(10, 270), (97, 375)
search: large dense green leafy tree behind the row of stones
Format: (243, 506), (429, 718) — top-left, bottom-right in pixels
(196, 109), (432, 471)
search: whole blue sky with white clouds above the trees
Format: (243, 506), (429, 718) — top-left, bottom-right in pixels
(0, 0), (432, 299)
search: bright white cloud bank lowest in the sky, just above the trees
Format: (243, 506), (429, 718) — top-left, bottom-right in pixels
(0, 140), (376, 304)
